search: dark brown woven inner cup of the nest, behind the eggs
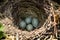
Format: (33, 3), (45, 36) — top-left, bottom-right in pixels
(12, 0), (48, 29)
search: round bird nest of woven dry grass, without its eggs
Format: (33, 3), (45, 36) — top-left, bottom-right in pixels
(0, 0), (59, 40)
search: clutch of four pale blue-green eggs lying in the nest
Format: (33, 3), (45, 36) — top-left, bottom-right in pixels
(19, 17), (39, 31)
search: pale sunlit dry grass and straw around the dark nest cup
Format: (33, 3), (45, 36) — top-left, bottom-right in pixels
(0, 0), (60, 40)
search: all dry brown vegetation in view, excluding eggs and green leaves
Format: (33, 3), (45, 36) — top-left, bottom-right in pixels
(0, 0), (60, 40)
